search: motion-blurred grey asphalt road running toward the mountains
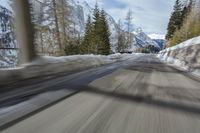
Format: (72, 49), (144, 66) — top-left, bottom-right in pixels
(1, 55), (200, 133)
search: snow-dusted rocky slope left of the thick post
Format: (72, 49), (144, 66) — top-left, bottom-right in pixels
(0, 6), (18, 68)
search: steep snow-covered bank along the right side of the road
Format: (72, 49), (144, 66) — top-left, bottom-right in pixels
(158, 36), (200, 77)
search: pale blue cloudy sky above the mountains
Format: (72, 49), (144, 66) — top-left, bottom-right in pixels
(86, 0), (175, 35)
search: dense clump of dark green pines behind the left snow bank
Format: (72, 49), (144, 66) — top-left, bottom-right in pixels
(80, 4), (110, 55)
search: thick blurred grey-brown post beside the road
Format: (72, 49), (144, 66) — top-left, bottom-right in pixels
(14, 0), (36, 64)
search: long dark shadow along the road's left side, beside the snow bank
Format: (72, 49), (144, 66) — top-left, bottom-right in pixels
(0, 63), (116, 108)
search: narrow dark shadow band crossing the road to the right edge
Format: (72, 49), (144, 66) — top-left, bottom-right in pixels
(81, 86), (200, 116)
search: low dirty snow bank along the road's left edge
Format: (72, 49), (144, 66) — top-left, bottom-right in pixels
(0, 54), (134, 84)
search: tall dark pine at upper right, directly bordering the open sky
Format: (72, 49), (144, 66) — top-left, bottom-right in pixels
(166, 0), (183, 40)
